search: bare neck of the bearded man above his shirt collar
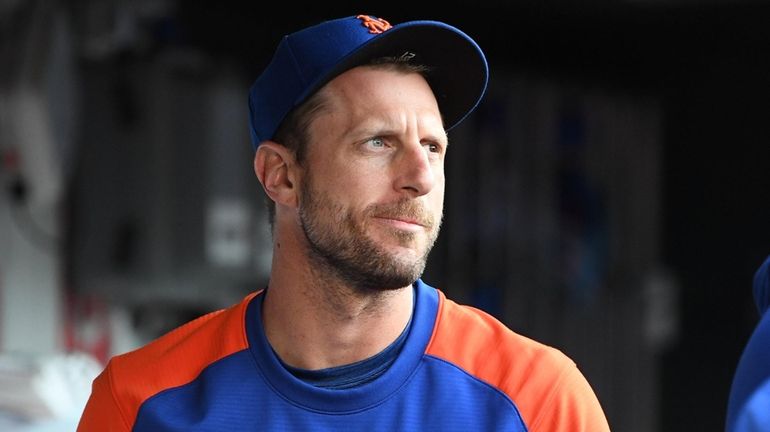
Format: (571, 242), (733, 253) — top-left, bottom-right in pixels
(263, 241), (414, 369)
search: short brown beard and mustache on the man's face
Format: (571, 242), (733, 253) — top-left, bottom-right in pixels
(299, 172), (441, 294)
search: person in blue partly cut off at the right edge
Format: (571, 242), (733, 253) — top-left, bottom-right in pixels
(725, 256), (770, 432)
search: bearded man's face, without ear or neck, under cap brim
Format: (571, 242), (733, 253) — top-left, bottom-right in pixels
(299, 67), (447, 291)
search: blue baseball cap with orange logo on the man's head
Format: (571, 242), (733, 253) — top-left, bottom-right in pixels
(249, 15), (489, 150)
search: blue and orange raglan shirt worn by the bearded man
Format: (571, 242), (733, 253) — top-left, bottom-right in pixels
(78, 280), (609, 432)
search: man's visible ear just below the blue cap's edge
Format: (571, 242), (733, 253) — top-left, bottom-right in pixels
(254, 141), (298, 207)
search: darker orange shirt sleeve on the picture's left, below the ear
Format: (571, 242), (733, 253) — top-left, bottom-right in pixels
(77, 293), (257, 432)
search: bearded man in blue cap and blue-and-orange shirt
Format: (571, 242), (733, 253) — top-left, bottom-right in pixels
(79, 15), (609, 432)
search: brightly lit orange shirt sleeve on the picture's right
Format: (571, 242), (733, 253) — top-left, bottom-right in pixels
(426, 291), (610, 432)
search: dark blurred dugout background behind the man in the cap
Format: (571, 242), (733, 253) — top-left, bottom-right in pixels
(0, 0), (770, 432)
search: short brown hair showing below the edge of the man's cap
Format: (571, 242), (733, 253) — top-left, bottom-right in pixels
(266, 53), (430, 230)
